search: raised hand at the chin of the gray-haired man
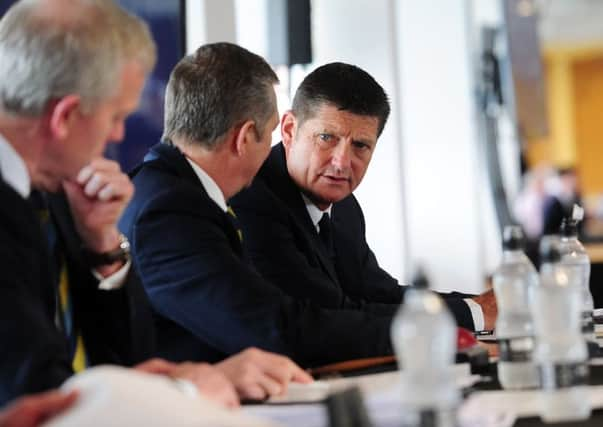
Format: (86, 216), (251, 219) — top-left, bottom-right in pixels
(63, 157), (134, 277)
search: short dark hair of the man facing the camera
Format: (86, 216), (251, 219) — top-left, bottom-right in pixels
(291, 62), (390, 136)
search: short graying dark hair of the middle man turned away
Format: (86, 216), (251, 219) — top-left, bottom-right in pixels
(162, 43), (278, 148)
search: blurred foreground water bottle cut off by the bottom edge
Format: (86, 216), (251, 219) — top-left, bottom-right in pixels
(391, 271), (461, 427)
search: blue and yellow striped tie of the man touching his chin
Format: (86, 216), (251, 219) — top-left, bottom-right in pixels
(32, 194), (88, 372)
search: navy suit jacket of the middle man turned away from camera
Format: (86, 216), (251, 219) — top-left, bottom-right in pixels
(120, 144), (392, 366)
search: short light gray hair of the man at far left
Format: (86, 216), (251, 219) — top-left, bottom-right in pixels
(0, 0), (156, 117)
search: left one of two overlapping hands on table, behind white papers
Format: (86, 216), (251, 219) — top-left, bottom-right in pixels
(135, 359), (239, 408)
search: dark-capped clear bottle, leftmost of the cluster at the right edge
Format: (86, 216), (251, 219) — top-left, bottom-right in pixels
(493, 226), (539, 389)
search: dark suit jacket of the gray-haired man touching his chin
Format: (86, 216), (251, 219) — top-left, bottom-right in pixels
(0, 179), (153, 406)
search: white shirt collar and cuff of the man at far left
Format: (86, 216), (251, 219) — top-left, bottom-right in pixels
(0, 134), (131, 291)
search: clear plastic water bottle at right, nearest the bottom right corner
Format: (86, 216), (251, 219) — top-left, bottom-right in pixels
(532, 242), (591, 422)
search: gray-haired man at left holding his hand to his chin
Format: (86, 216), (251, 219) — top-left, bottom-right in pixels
(0, 0), (308, 405)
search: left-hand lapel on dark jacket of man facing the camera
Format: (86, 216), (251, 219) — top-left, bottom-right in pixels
(260, 143), (339, 285)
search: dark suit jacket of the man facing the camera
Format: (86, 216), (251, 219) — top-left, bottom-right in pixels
(231, 144), (473, 329)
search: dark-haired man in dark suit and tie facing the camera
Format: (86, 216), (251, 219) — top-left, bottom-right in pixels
(231, 63), (496, 329)
